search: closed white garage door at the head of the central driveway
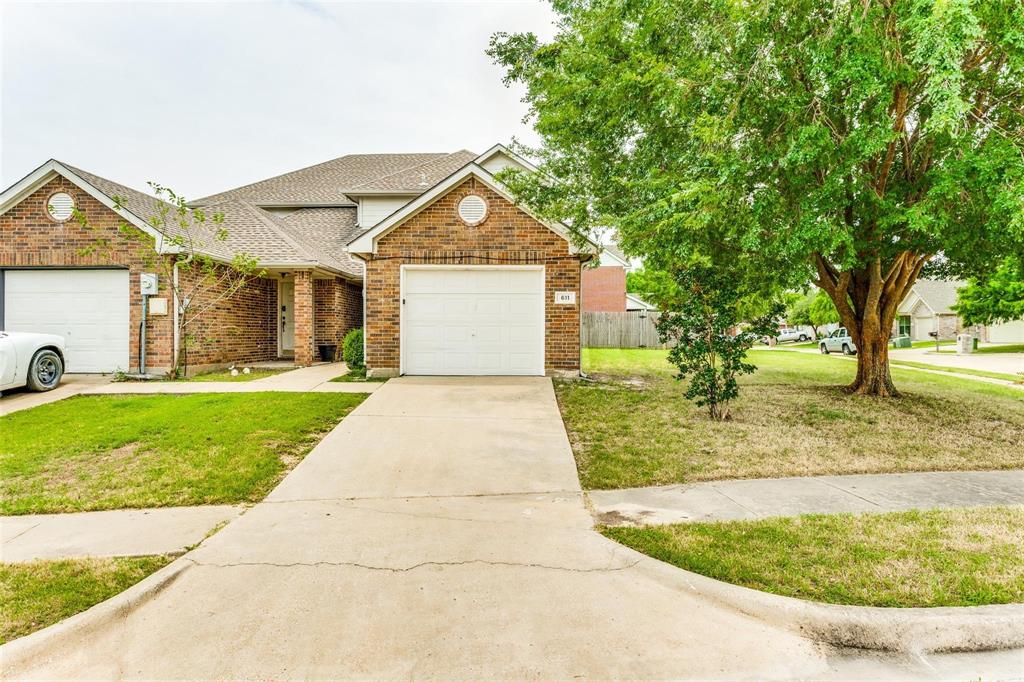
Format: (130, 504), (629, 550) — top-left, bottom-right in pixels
(401, 266), (544, 375)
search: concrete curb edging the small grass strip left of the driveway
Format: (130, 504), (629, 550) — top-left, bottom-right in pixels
(0, 554), (195, 678)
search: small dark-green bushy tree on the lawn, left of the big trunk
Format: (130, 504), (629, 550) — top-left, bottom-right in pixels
(657, 265), (782, 421)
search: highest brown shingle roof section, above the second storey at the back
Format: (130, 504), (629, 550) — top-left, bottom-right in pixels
(193, 151), (474, 206)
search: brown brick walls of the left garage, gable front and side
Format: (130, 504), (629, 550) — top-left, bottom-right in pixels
(0, 177), (278, 372)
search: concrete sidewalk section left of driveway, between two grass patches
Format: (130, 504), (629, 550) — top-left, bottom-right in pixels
(0, 505), (243, 563)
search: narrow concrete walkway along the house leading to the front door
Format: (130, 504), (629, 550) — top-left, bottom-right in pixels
(83, 363), (382, 395)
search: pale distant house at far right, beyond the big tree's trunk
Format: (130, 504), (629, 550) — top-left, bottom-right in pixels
(893, 280), (1024, 343)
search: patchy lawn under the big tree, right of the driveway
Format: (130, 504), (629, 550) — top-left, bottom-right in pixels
(556, 349), (1024, 488)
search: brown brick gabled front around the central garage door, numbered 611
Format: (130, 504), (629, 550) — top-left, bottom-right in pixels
(366, 178), (581, 371)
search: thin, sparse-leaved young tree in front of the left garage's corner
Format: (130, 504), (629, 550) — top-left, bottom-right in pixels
(74, 182), (265, 378)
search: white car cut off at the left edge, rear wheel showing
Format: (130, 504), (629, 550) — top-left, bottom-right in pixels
(0, 332), (65, 391)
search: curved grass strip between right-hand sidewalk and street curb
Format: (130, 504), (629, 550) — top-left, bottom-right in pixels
(601, 507), (1024, 606)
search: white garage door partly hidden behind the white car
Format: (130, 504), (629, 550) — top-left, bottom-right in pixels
(4, 269), (130, 372)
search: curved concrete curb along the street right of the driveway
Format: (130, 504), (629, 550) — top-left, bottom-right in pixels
(630, 541), (1024, 654)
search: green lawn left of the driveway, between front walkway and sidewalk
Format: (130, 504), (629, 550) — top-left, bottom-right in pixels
(0, 392), (366, 514)
